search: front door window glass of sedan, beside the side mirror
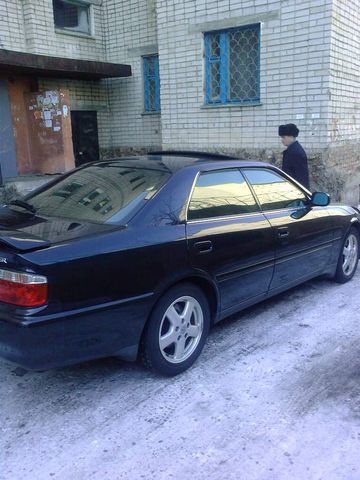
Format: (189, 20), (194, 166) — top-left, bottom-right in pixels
(242, 168), (308, 210)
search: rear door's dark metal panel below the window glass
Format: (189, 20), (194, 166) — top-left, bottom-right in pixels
(186, 213), (275, 311)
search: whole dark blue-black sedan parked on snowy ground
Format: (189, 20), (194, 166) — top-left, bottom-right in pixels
(0, 154), (360, 375)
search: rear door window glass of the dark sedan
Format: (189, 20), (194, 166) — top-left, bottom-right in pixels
(188, 169), (259, 220)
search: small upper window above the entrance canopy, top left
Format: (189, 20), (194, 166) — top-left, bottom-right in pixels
(53, 0), (90, 33)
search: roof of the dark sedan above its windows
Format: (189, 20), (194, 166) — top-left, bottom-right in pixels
(92, 153), (273, 173)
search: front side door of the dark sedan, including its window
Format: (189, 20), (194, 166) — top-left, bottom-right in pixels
(243, 167), (333, 291)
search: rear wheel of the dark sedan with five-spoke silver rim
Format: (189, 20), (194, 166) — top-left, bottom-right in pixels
(140, 283), (210, 377)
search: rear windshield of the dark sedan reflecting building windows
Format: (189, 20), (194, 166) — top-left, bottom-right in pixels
(26, 162), (170, 224)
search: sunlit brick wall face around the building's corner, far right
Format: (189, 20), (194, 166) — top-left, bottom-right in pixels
(327, 0), (360, 204)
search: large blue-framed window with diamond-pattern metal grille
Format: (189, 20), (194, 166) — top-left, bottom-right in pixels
(204, 24), (260, 105)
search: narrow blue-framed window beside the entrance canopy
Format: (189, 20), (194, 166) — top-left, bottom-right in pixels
(142, 55), (160, 113)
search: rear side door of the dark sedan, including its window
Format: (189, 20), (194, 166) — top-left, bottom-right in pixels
(186, 168), (275, 311)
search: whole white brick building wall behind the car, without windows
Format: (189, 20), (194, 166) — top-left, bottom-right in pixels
(0, 0), (360, 203)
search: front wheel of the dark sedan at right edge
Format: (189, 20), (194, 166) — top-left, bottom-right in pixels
(334, 228), (360, 283)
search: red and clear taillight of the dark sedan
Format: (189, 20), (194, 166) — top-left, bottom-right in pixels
(0, 269), (48, 307)
